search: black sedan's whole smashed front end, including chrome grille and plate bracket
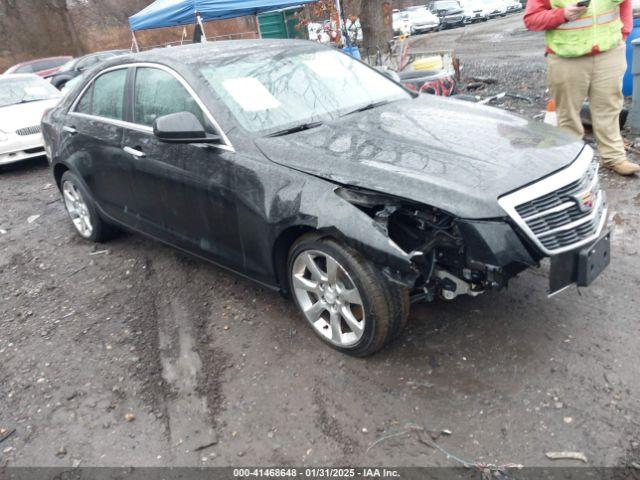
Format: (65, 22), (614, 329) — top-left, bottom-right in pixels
(336, 147), (610, 300)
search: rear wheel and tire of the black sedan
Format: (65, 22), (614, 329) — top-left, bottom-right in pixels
(60, 171), (116, 242)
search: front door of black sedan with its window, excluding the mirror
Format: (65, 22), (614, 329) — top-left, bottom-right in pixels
(123, 66), (241, 268)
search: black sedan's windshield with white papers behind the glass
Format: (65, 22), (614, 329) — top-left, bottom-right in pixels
(201, 48), (411, 135)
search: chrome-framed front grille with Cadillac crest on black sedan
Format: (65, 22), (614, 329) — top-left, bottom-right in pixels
(500, 148), (607, 255)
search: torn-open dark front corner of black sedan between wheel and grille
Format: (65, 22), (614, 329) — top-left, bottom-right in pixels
(336, 189), (541, 300)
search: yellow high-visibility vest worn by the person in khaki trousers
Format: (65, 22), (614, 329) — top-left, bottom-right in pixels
(545, 0), (622, 58)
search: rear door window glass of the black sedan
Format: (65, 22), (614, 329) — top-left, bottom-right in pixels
(76, 68), (127, 120)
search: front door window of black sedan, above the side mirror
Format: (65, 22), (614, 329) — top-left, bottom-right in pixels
(133, 68), (212, 131)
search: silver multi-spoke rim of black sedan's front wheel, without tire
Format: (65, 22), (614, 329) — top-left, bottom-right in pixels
(291, 250), (365, 347)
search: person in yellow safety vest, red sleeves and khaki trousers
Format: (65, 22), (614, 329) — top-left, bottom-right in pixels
(524, 0), (640, 175)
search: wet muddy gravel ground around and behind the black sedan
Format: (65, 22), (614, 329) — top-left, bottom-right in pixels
(0, 16), (640, 468)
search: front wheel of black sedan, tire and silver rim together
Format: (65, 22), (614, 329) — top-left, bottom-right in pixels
(287, 236), (409, 357)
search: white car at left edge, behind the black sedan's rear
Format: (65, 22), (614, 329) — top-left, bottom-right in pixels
(0, 74), (62, 165)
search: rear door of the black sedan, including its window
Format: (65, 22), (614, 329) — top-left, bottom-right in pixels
(63, 68), (135, 223)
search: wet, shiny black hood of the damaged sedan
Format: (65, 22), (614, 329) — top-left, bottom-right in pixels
(256, 95), (584, 219)
